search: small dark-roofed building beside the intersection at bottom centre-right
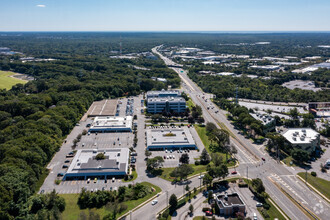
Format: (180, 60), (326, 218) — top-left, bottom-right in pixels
(214, 193), (245, 216)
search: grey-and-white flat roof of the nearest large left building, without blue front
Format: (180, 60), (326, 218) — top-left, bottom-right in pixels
(67, 148), (129, 174)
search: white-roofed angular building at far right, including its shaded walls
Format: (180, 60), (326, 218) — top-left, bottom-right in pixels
(283, 128), (320, 153)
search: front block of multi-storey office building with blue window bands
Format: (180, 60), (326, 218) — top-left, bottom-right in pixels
(147, 97), (186, 114)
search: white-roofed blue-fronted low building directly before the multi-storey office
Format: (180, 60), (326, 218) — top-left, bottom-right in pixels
(146, 127), (197, 150)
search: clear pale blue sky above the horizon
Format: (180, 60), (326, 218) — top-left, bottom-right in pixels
(0, 0), (330, 32)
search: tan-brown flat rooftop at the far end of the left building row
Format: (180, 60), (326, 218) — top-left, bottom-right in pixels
(87, 99), (118, 117)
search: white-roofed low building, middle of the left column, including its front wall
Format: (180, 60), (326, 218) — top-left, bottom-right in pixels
(89, 116), (133, 132)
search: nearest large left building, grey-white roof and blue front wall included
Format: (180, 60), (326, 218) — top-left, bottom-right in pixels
(63, 148), (129, 180)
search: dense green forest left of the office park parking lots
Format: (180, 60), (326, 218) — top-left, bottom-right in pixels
(0, 34), (180, 219)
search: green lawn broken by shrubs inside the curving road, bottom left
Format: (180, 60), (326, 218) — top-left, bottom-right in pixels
(60, 182), (161, 220)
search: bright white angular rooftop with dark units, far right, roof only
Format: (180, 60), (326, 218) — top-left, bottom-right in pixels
(283, 128), (320, 144)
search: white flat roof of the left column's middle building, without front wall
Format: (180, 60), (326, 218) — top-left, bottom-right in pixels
(90, 116), (133, 130)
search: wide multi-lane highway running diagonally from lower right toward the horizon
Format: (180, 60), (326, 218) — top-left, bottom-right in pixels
(148, 47), (330, 219)
